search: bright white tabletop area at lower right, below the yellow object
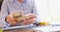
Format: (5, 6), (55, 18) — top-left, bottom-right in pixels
(33, 26), (60, 32)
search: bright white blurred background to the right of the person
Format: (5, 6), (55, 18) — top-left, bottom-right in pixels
(35, 0), (60, 24)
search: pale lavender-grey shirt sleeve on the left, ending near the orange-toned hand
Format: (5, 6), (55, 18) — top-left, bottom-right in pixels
(0, 0), (8, 28)
